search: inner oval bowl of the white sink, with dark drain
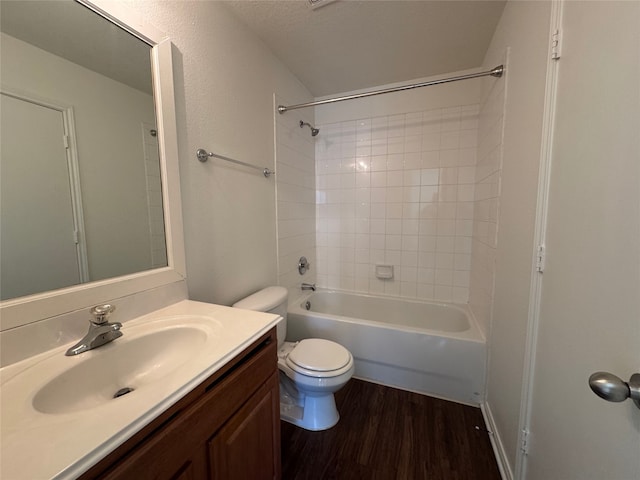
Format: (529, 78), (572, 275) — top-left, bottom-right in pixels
(33, 322), (208, 413)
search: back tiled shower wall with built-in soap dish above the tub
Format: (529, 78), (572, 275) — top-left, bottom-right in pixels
(315, 104), (485, 303)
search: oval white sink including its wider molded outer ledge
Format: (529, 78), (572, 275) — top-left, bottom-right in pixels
(2, 315), (221, 415)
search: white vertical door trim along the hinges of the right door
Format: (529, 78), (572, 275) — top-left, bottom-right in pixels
(515, 0), (564, 480)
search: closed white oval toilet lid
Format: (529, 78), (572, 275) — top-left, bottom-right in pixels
(287, 338), (351, 372)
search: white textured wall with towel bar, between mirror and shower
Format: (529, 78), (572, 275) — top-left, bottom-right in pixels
(122, 0), (310, 304)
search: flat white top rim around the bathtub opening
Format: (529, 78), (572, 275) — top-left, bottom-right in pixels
(287, 287), (487, 344)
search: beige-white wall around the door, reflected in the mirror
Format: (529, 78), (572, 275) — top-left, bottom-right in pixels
(1, 33), (155, 281)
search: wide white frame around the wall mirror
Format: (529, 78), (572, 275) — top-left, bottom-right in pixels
(0, 0), (186, 331)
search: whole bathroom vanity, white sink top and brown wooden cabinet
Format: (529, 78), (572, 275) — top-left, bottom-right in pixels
(0, 300), (281, 479)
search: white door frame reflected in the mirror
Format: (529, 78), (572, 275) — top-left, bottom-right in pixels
(0, 85), (90, 283)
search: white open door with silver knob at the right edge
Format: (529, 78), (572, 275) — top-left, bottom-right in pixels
(526, 1), (640, 480)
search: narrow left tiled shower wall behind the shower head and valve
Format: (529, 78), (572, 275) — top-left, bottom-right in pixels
(275, 97), (317, 300)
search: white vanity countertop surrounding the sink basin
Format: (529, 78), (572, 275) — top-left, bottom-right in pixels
(0, 300), (280, 480)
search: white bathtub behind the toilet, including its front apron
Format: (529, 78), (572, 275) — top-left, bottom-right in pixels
(287, 290), (486, 406)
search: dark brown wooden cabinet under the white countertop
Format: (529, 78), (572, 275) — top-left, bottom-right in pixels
(80, 329), (281, 480)
